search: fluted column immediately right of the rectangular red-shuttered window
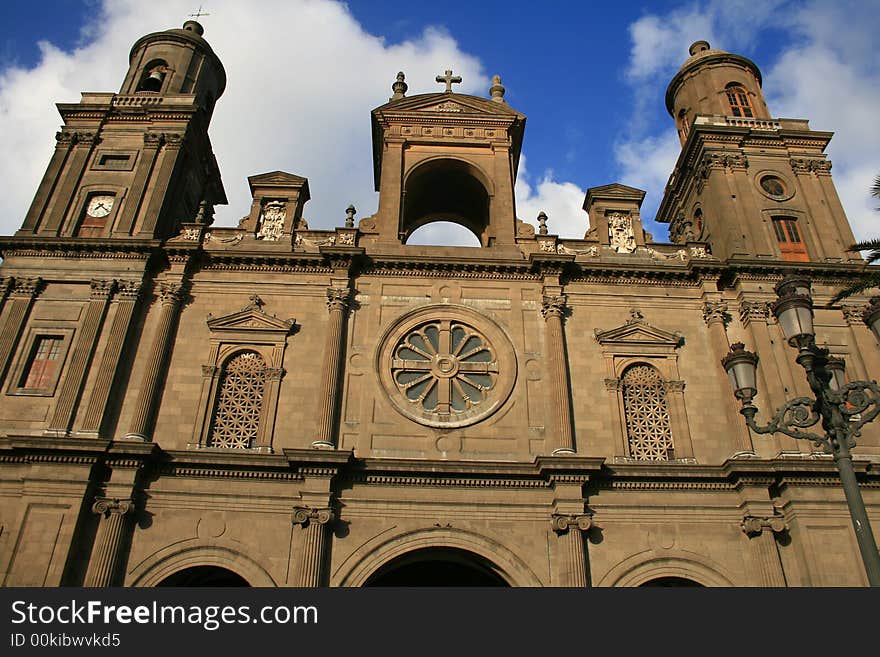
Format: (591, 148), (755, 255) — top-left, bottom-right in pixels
(46, 280), (116, 436)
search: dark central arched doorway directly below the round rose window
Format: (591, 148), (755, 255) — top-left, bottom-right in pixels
(364, 548), (509, 586)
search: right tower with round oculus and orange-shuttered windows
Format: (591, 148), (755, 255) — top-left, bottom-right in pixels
(657, 41), (861, 262)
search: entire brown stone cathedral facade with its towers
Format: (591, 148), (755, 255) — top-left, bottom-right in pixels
(0, 21), (880, 587)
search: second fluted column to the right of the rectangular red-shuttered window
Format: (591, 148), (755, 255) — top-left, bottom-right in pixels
(80, 281), (141, 434)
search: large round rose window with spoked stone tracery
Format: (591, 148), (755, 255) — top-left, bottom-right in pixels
(377, 305), (516, 427)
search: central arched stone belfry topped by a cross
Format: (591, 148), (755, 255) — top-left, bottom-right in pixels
(360, 71), (526, 249)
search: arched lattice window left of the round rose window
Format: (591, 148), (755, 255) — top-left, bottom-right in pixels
(208, 351), (266, 449)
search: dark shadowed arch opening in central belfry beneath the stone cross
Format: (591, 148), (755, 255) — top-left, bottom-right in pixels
(400, 158), (491, 246)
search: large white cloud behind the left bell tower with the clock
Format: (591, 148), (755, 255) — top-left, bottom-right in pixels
(0, 0), (490, 234)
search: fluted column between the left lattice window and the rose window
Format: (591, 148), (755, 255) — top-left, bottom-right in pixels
(312, 287), (351, 449)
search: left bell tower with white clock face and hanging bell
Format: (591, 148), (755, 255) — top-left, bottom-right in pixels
(17, 21), (226, 239)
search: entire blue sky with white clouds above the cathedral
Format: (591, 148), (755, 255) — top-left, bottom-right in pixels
(0, 0), (880, 241)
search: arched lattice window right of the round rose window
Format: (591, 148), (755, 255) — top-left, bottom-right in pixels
(621, 363), (675, 461)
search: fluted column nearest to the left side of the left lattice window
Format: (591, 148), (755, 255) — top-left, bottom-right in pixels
(125, 283), (184, 441)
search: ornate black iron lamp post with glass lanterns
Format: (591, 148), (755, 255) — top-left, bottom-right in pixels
(721, 276), (880, 586)
